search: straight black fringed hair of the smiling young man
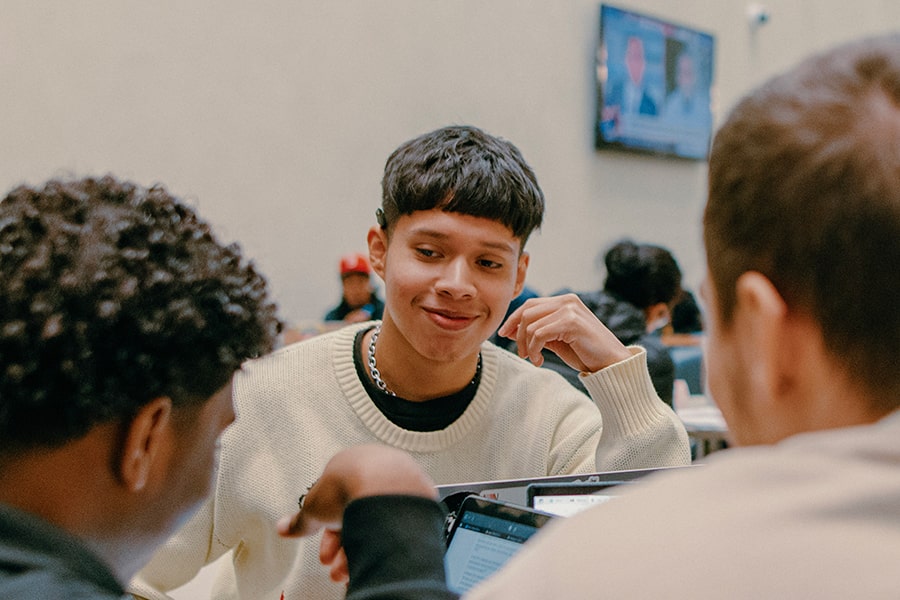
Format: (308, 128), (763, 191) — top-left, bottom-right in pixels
(381, 126), (544, 247)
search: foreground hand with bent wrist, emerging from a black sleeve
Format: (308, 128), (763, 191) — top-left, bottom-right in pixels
(278, 444), (437, 583)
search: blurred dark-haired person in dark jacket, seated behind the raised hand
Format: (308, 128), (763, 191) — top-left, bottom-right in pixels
(544, 239), (681, 406)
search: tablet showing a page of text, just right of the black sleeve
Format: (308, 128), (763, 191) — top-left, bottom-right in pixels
(444, 495), (553, 594)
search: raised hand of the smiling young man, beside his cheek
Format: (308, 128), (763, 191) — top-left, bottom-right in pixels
(497, 294), (631, 373)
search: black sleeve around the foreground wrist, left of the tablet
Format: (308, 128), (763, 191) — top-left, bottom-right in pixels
(341, 496), (457, 600)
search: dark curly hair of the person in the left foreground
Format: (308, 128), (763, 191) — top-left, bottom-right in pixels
(0, 176), (279, 451)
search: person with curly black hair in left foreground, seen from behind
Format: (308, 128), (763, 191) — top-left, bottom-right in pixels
(0, 176), (280, 598)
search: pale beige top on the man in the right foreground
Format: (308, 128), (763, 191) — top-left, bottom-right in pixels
(464, 408), (900, 600)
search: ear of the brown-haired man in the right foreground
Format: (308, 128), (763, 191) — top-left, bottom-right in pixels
(734, 271), (793, 400)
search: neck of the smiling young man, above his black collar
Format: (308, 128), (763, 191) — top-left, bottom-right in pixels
(363, 321), (479, 402)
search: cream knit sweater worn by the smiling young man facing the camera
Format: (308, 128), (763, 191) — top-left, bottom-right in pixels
(131, 323), (690, 600)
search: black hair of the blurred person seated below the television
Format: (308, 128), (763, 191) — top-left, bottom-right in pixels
(603, 240), (681, 310)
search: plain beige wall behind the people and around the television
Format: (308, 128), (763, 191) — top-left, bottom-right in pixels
(0, 0), (900, 319)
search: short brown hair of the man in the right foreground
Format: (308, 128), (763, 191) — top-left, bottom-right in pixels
(704, 35), (900, 406)
